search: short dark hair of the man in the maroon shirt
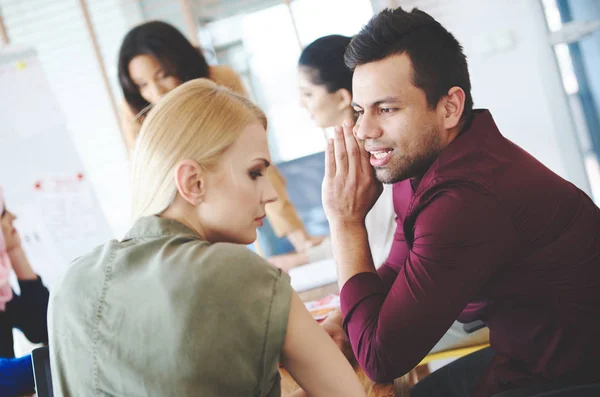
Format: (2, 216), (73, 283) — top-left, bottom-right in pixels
(344, 7), (473, 120)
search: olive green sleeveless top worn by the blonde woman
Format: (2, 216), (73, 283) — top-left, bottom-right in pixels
(49, 217), (291, 397)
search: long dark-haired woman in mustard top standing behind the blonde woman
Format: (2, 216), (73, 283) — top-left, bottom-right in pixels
(118, 21), (321, 252)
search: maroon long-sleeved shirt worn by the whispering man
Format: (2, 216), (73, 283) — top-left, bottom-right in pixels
(341, 110), (600, 397)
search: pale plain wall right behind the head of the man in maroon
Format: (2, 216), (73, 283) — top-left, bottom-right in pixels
(374, 0), (590, 194)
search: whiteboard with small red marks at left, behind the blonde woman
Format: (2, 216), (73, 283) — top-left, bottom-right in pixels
(0, 48), (112, 287)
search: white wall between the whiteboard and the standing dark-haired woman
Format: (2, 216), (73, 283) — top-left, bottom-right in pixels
(0, 0), (141, 236)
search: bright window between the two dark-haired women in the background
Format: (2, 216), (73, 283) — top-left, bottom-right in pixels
(207, 0), (372, 162)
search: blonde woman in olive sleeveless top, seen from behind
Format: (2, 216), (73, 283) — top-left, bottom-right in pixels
(49, 79), (365, 396)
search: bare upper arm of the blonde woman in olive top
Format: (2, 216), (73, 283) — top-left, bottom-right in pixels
(282, 292), (366, 397)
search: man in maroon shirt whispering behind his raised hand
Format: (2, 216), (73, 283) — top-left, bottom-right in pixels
(323, 8), (600, 397)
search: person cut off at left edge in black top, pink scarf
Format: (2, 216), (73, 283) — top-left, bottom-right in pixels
(0, 187), (48, 396)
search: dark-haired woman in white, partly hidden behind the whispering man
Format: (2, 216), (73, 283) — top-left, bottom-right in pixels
(269, 35), (396, 271)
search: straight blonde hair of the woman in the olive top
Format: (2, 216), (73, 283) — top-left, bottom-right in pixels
(133, 79), (267, 219)
